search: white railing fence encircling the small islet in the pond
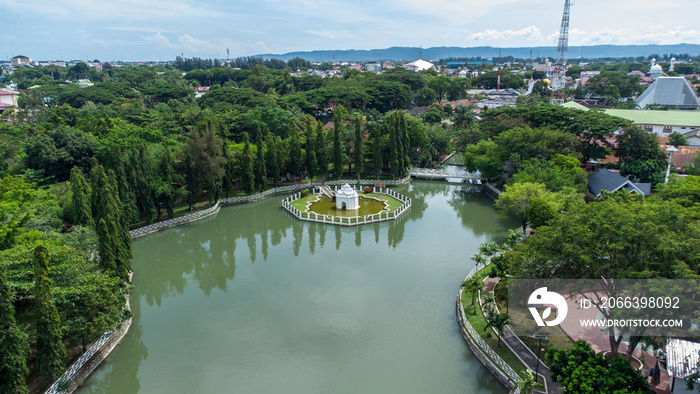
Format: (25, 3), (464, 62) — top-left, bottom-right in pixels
(282, 186), (411, 226)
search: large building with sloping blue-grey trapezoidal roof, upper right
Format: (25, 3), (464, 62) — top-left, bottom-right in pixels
(636, 77), (700, 109)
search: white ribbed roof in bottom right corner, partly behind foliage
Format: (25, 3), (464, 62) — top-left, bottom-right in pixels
(666, 338), (700, 394)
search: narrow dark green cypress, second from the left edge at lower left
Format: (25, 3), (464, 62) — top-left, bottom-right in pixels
(33, 245), (66, 379)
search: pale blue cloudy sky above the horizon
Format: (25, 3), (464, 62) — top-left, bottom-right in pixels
(0, 0), (700, 61)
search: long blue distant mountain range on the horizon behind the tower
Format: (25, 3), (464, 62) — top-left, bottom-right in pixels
(256, 44), (700, 62)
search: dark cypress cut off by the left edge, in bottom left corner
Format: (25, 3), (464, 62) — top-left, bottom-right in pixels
(0, 269), (29, 393)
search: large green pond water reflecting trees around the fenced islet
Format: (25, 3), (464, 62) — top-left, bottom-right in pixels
(80, 181), (518, 394)
